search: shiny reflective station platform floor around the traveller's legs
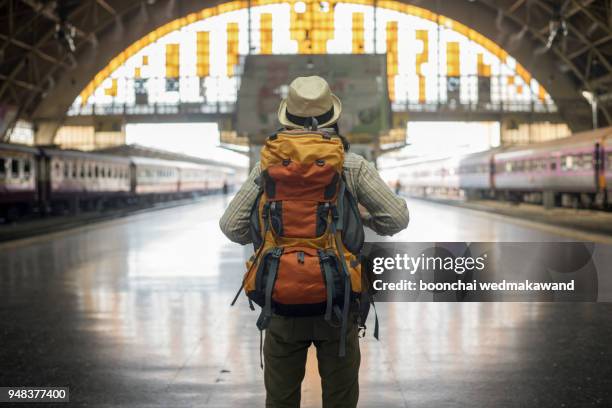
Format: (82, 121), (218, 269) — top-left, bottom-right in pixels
(0, 197), (612, 408)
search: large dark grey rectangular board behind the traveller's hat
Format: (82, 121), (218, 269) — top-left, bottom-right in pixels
(236, 54), (391, 144)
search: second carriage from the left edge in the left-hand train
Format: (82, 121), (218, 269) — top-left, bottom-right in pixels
(39, 148), (130, 213)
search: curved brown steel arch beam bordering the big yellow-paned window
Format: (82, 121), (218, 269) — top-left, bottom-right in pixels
(26, 0), (590, 143)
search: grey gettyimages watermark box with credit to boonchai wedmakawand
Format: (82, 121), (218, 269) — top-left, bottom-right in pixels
(363, 242), (612, 301)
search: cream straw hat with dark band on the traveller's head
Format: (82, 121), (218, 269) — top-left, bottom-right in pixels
(278, 76), (342, 128)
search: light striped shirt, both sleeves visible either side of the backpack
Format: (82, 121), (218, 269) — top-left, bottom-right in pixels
(219, 153), (409, 245)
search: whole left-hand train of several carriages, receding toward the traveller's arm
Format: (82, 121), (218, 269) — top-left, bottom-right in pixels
(0, 143), (243, 222)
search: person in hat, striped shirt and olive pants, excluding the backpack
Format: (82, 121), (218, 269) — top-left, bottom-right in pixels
(219, 76), (409, 408)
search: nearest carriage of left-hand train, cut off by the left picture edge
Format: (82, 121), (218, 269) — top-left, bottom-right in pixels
(0, 143), (38, 220)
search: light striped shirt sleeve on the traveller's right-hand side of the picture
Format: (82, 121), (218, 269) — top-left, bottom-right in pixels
(355, 159), (410, 235)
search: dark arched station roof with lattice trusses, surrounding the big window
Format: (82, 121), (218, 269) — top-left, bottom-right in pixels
(0, 0), (612, 139)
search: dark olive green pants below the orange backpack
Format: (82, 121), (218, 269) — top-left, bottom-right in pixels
(263, 316), (361, 408)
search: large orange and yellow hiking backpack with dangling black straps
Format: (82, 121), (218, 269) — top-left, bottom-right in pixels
(232, 129), (378, 356)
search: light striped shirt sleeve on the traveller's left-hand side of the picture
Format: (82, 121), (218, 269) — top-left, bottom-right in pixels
(219, 163), (261, 245)
